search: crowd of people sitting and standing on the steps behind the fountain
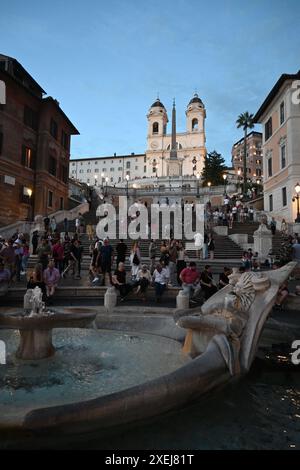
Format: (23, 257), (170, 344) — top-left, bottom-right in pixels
(0, 204), (300, 310)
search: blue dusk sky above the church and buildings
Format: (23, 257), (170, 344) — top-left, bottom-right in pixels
(0, 0), (300, 163)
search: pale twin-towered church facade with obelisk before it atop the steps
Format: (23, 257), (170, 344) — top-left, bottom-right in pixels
(146, 94), (206, 177)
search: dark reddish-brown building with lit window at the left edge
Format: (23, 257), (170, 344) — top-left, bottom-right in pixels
(0, 55), (79, 225)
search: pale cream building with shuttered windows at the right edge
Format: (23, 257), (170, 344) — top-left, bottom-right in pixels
(254, 71), (300, 222)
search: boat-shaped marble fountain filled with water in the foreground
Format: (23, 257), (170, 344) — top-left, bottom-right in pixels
(0, 263), (295, 447)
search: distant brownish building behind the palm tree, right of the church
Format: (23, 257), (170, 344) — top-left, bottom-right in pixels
(231, 131), (263, 183)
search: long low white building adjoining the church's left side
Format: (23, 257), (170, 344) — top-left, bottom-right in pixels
(70, 153), (147, 186)
